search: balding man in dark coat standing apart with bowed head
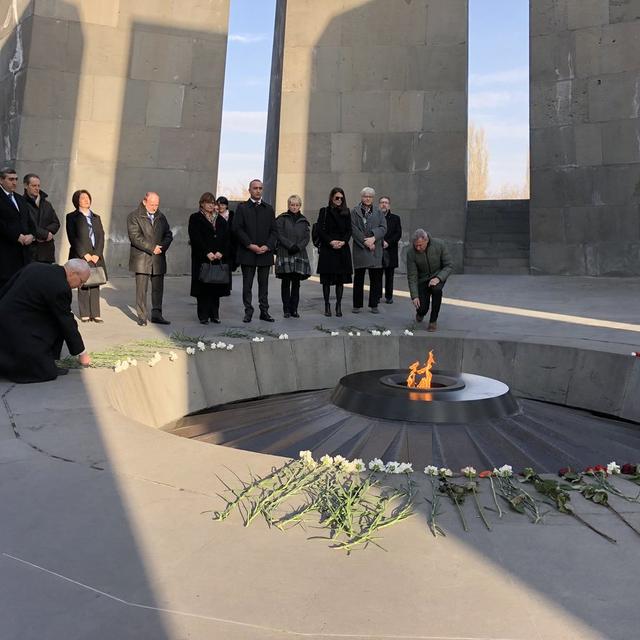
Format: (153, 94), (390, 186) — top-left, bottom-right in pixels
(127, 191), (173, 327)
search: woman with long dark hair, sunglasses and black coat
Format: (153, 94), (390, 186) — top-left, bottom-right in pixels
(317, 187), (353, 317)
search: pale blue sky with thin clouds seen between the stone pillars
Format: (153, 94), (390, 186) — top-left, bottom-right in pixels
(218, 0), (529, 194)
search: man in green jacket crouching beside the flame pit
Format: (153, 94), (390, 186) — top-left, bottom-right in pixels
(407, 229), (453, 331)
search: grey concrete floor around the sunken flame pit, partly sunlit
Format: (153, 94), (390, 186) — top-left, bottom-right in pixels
(0, 276), (640, 640)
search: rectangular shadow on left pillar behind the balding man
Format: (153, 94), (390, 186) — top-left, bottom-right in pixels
(107, 22), (227, 275)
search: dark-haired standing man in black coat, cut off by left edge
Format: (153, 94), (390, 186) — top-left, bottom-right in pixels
(0, 168), (36, 287)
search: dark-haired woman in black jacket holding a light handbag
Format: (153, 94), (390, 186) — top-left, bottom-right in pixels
(66, 189), (107, 322)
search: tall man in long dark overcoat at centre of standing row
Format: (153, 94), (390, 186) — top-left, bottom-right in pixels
(232, 180), (278, 322)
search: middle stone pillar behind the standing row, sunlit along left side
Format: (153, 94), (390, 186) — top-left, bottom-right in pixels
(265, 0), (468, 267)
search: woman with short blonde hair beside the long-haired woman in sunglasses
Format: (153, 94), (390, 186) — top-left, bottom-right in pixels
(275, 195), (311, 318)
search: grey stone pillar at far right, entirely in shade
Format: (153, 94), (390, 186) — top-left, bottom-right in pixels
(530, 0), (640, 276)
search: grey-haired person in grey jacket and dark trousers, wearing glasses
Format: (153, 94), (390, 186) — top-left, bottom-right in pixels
(351, 187), (387, 313)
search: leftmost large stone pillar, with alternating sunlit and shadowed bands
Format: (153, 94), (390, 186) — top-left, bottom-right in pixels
(0, 0), (229, 273)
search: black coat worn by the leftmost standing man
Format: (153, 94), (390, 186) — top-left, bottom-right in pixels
(0, 188), (36, 284)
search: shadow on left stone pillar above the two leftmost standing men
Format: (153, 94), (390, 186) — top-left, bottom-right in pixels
(0, 0), (84, 261)
